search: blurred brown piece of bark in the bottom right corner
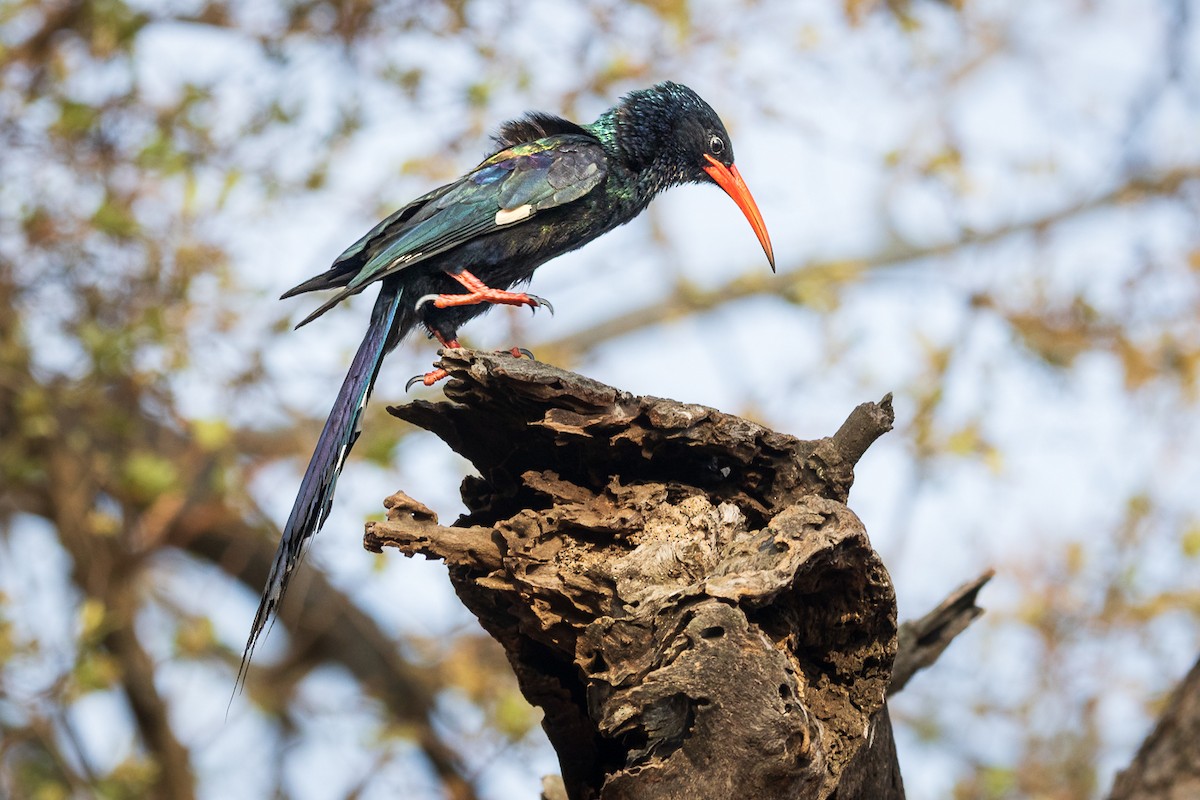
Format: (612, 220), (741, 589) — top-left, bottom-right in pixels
(1109, 661), (1200, 800)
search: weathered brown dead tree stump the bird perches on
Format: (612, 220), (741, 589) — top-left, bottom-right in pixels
(366, 350), (904, 800)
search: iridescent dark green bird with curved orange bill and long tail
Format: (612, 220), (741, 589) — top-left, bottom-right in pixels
(234, 82), (775, 693)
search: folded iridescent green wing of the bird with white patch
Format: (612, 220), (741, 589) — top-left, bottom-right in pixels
(289, 133), (607, 325)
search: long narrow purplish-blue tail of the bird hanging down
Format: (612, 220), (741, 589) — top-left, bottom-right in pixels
(234, 281), (415, 693)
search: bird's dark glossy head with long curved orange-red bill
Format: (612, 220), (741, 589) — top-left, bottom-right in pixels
(616, 82), (775, 270)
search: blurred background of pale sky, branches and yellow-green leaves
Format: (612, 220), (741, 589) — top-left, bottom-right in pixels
(0, 0), (1200, 800)
